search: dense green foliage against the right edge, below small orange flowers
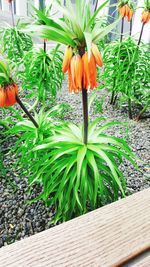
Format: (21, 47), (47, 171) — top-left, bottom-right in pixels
(103, 38), (150, 116)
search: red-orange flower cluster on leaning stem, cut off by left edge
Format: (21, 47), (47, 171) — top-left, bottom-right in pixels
(0, 84), (18, 108)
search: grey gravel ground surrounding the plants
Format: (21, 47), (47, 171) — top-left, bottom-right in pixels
(0, 82), (150, 247)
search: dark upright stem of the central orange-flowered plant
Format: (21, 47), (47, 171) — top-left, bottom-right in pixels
(79, 47), (88, 144)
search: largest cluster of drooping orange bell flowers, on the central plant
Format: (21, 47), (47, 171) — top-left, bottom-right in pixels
(62, 43), (103, 93)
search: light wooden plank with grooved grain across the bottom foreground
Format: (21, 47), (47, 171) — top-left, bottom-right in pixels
(0, 189), (150, 267)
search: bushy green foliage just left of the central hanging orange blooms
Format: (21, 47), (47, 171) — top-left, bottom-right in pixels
(20, 45), (64, 103)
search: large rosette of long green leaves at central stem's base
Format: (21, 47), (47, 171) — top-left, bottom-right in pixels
(22, 118), (136, 223)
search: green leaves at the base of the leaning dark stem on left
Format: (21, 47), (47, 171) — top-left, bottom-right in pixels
(6, 105), (63, 172)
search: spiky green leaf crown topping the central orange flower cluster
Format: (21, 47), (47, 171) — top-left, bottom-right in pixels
(29, 0), (118, 53)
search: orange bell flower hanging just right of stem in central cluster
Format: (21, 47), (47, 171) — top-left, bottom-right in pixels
(82, 52), (96, 89)
